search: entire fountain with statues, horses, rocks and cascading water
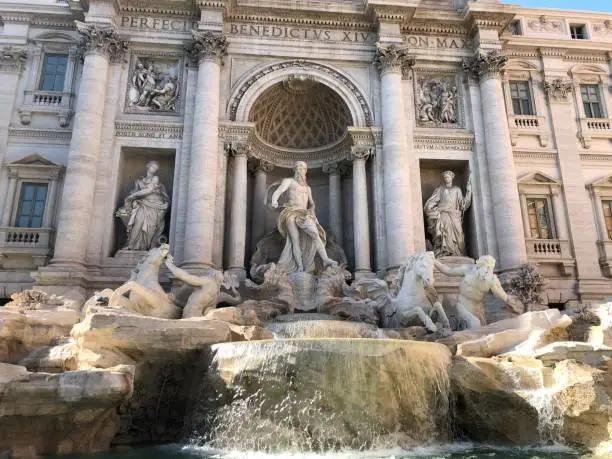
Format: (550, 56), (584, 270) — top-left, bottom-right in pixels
(0, 159), (612, 458)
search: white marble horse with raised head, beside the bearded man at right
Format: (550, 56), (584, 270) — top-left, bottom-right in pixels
(383, 252), (450, 332)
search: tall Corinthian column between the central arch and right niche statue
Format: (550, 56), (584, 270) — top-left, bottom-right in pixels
(374, 44), (413, 268)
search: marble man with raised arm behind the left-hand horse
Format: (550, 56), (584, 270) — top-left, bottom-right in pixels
(166, 255), (242, 319)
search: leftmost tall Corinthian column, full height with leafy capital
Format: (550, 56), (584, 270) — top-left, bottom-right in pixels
(51, 21), (127, 266)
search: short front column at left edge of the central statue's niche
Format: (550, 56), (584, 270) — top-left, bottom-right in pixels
(227, 144), (249, 279)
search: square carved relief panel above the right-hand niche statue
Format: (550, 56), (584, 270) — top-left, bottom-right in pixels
(417, 77), (458, 126)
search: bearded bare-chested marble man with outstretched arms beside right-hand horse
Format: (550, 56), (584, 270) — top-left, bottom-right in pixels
(435, 255), (525, 330)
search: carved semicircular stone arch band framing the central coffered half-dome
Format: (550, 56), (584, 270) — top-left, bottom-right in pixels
(226, 59), (373, 127)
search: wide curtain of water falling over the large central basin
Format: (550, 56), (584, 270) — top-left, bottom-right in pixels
(186, 339), (451, 452)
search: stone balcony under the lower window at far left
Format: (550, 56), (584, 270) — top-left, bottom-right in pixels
(0, 227), (53, 267)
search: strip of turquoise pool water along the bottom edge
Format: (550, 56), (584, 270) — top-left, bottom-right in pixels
(71, 443), (588, 459)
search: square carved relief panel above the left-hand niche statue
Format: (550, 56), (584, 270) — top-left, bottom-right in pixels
(128, 59), (179, 112)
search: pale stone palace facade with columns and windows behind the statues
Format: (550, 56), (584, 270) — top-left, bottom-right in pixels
(0, 0), (612, 310)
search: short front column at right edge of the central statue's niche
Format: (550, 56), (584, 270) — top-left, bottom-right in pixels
(351, 147), (372, 278)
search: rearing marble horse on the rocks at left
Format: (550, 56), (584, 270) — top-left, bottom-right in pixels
(108, 244), (181, 319)
